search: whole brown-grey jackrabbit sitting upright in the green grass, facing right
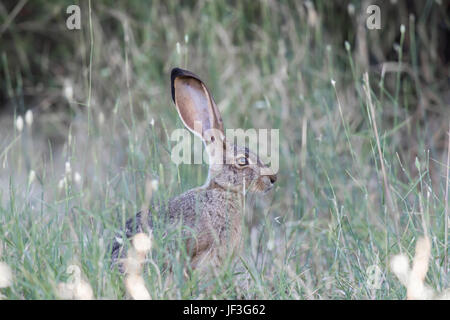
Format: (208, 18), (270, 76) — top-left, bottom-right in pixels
(112, 68), (277, 272)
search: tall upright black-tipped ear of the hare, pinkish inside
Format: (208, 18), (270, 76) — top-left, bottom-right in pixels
(170, 68), (224, 144)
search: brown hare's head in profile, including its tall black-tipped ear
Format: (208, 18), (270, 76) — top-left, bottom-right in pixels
(171, 68), (277, 193)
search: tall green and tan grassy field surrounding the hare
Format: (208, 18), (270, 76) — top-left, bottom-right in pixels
(0, 0), (450, 299)
